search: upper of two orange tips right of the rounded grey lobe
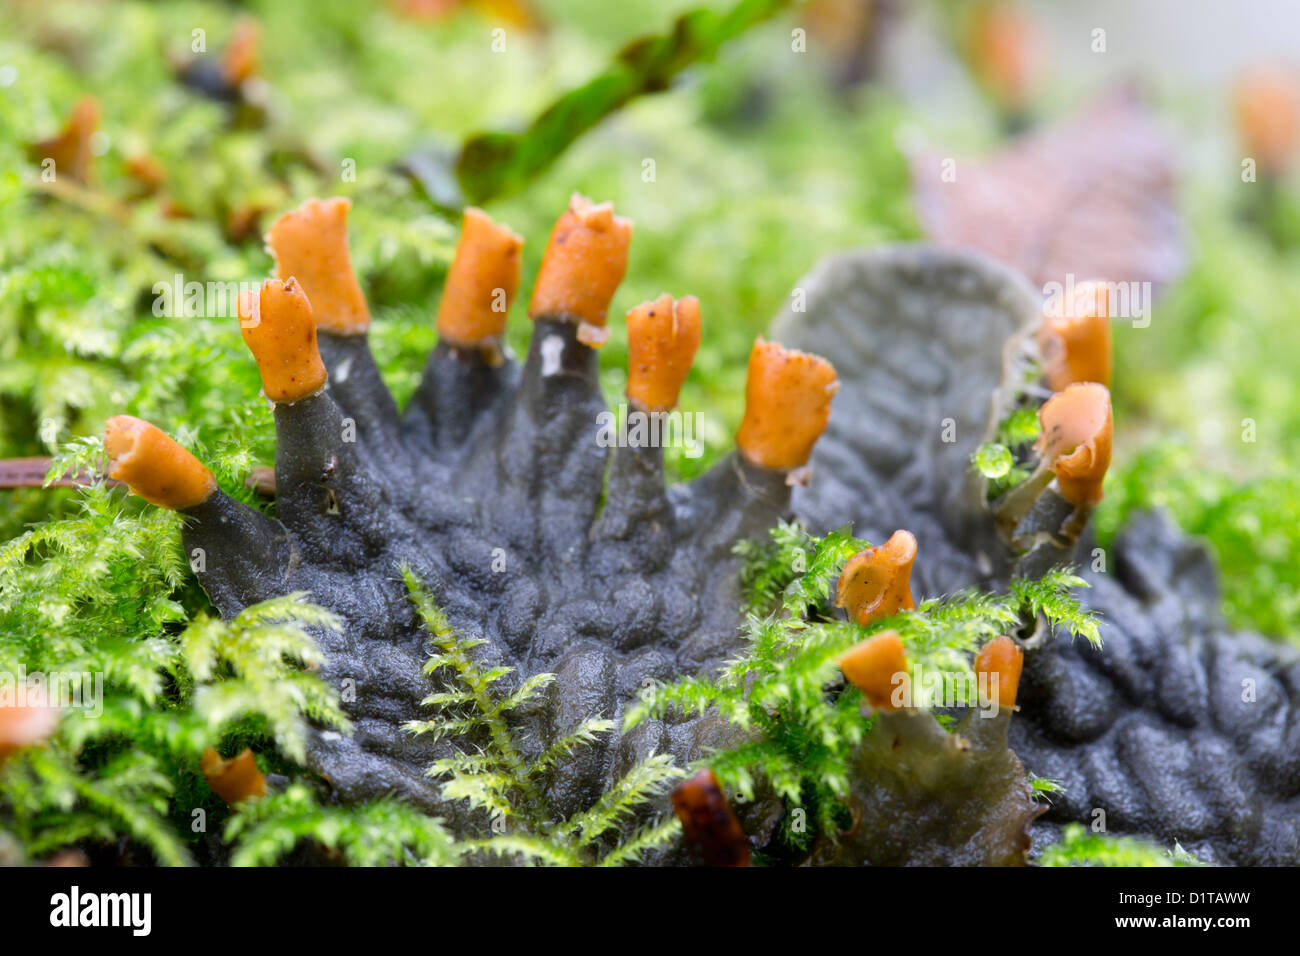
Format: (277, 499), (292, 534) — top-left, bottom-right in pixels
(1037, 282), (1112, 392)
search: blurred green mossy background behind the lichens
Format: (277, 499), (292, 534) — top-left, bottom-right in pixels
(0, 0), (1300, 637)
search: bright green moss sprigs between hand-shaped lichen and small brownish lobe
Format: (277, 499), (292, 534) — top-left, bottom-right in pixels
(625, 524), (1100, 848)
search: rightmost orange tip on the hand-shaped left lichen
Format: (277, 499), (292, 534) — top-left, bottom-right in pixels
(736, 337), (840, 468)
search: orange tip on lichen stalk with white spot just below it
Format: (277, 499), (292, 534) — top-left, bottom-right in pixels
(528, 193), (632, 347)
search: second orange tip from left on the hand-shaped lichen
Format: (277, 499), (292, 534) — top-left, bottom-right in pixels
(239, 277), (326, 403)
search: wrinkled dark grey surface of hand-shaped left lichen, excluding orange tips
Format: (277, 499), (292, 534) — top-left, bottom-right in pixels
(186, 314), (789, 837)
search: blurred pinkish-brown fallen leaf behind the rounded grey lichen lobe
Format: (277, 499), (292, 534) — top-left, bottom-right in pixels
(911, 90), (1187, 297)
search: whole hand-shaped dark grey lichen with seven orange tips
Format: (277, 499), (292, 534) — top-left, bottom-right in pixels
(107, 196), (839, 831)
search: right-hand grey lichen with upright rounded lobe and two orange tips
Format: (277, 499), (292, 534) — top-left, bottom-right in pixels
(772, 251), (1300, 865)
